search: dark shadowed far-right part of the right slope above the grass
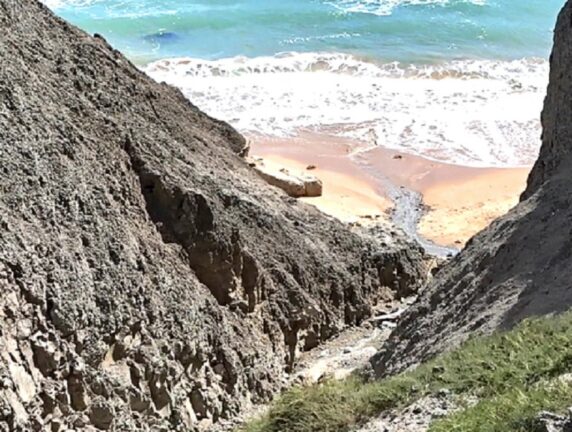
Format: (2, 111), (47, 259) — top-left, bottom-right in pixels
(493, 160), (572, 327)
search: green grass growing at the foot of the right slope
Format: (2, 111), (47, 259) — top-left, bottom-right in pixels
(242, 313), (572, 432)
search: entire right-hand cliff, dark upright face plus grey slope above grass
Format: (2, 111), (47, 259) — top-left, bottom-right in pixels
(373, 1), (572, 375)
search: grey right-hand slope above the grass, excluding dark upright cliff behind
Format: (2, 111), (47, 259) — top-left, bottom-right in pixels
(373, 157), (572, 375)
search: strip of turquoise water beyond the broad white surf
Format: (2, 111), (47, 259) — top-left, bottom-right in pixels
(43, 0), (562, 62)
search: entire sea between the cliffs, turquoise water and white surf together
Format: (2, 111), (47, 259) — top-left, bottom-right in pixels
(44, 0), (563, 166)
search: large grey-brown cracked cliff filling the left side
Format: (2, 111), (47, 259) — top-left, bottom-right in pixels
(0, 0), (425, 432)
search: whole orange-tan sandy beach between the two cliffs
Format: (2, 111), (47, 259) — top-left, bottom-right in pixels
(250, 133), (530, 248)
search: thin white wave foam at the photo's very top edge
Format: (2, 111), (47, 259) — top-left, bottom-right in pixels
(326, 0), (487, 16)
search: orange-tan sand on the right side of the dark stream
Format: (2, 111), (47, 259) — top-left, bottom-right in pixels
(359, 147), (530, 247)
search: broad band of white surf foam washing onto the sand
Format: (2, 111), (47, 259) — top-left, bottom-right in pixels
(145, 53), (548, 166)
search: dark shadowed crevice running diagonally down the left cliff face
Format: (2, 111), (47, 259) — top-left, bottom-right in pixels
(124, 133), (262, 312)
